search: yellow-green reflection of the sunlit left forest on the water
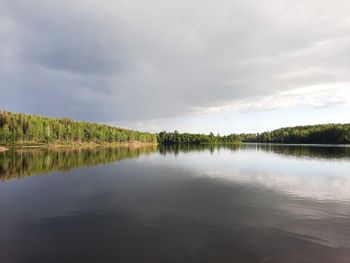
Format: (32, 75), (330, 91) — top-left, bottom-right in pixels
(0, 145), (156, 180)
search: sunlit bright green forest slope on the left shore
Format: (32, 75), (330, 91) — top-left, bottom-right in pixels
(0, 111), (157, 145)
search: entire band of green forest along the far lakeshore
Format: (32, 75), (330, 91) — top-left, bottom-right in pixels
(0, 111), (350, 146)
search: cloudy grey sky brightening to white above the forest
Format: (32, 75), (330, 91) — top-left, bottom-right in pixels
(0, 0), (350, 134)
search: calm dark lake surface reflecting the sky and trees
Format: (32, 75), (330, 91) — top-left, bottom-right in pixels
(0, 144), (350, 263)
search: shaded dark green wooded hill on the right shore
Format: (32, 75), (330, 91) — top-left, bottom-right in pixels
(243, 124), (350, 144)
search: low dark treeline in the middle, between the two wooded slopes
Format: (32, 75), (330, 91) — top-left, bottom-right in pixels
(157, 131), (242, 144)
